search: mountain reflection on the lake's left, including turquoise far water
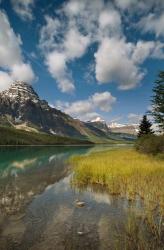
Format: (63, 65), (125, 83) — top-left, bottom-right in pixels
(0, 147), (91, 215)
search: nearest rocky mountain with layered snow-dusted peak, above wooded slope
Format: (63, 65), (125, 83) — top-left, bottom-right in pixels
(0, 81), (92, 137)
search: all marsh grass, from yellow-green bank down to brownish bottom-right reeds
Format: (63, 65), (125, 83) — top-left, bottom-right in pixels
(70, 148), (164, 249)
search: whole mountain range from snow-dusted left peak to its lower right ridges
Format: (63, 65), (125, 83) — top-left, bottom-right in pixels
(0, 81), (136, 143)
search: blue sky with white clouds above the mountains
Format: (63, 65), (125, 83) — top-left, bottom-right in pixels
(0, 0), (164, 123)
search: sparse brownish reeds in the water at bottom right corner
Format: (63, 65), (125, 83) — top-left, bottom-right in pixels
(115, 211), (164, 250)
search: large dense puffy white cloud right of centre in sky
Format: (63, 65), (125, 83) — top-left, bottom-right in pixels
(95, 38), (143, 89)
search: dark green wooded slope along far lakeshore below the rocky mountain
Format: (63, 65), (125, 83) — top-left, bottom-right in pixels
(0, 127), (91, 145)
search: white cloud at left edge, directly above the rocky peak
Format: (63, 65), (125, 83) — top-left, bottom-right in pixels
(0, 11), (35, 90)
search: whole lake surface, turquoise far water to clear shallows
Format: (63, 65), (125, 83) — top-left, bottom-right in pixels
(0, 146), (161, 250)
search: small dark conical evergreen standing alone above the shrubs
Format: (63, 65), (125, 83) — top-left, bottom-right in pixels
(138, 115), (153, 137)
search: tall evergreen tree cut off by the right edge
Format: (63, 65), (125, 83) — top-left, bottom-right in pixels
(151, 71), (164, 132)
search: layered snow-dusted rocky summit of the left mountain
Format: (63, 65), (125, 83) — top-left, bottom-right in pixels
(1, 81), (39, 102)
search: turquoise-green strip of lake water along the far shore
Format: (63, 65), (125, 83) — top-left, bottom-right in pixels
(0, 146), (89, 177)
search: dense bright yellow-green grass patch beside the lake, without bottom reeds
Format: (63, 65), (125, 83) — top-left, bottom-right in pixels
(70, 149), (164, 215)
